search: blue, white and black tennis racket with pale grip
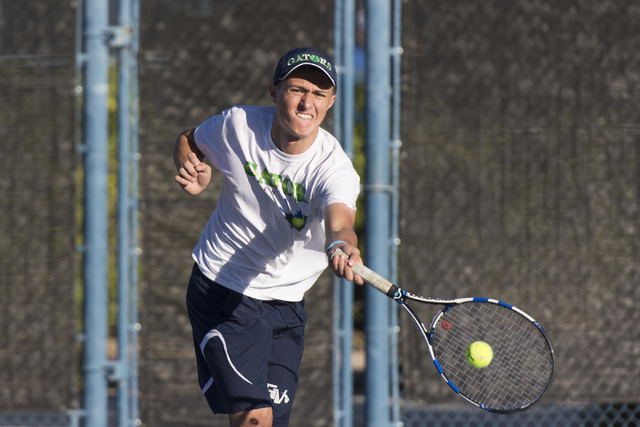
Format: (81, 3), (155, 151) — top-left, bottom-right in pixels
(333, 249), (555, 414)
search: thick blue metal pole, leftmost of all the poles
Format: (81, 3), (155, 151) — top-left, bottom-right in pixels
(83, 0), (109, 427)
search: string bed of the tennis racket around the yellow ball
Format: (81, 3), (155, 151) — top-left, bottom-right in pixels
(431, 302), (553, 411)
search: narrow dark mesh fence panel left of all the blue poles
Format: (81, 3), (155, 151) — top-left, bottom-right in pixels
(0, 0), (76, 425)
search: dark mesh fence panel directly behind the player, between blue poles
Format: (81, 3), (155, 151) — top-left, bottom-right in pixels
(140, 0), (333, 426)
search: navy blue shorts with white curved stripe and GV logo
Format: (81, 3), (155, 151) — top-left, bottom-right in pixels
(187, 265), (307, 427)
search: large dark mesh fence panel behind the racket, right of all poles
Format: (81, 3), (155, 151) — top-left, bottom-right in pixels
(401, 0), (640, 426)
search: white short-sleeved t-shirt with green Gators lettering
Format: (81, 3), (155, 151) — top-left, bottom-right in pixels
(193, 106), (360, 301)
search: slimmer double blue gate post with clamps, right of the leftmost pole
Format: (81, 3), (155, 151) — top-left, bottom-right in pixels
(111, 0), (141, 427)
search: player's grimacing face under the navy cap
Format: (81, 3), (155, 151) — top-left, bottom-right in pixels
(269, 67), (336, 144)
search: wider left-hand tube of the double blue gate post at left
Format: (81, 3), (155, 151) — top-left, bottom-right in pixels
(117, 0), (132, 427)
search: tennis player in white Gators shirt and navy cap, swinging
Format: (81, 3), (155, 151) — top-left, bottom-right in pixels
(173, 48), (362, 427)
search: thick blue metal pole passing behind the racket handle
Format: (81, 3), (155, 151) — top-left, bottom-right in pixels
(365, 0), (391, 427)
